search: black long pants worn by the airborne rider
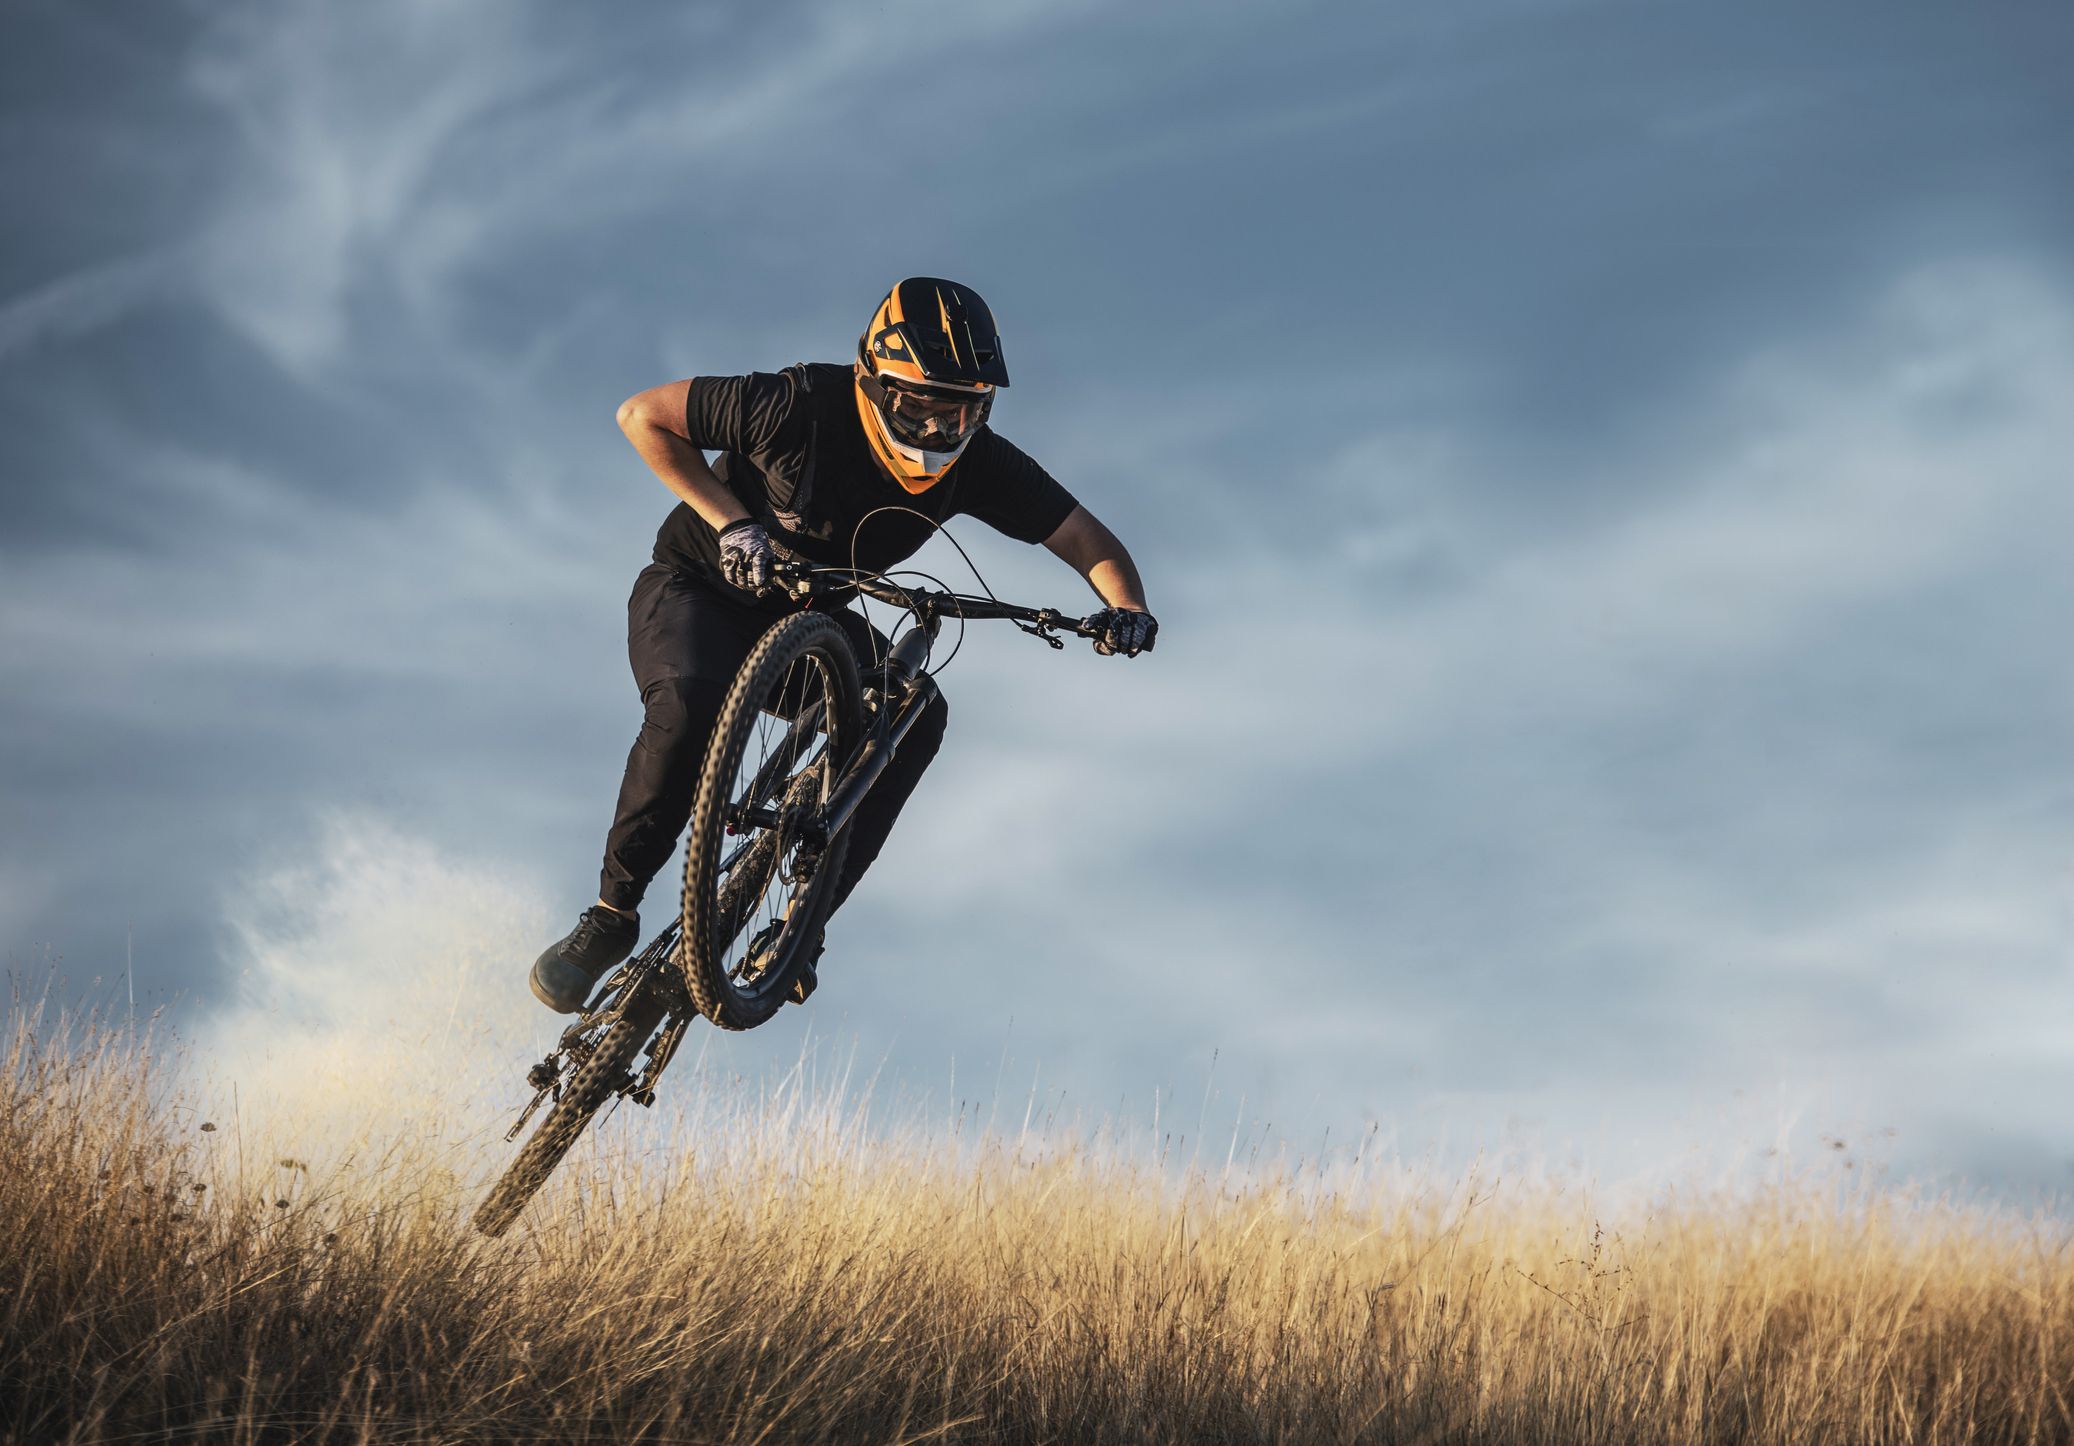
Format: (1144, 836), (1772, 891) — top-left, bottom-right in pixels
(597, 562), (950, 909)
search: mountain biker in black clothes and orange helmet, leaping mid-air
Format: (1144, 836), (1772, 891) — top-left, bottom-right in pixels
(531, 276), (1159, 1014)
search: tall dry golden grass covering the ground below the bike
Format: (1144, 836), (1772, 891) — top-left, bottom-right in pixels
(0, 1010), (2074, 1442)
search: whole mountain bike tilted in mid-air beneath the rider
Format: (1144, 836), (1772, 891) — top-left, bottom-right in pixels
(475, 562), (1136, 1236)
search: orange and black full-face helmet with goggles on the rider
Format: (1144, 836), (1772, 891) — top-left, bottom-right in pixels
(857, 276), (1008, 494)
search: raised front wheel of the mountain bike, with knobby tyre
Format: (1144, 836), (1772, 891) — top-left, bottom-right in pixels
(678, 612), (863, 1029)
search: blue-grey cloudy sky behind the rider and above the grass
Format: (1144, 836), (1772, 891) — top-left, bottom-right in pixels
(0, 0), (2074, 1195)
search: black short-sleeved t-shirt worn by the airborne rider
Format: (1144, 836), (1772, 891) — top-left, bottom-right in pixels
(655, 361), (1076, 591)
